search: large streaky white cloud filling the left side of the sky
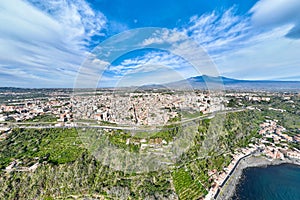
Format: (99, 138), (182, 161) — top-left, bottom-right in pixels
(0, 0), (106, 87)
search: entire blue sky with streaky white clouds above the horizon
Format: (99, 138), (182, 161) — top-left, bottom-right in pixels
(0, 0), (300, 88)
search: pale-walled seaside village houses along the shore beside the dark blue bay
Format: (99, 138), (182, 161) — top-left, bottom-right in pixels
(205, 119), (300, 200)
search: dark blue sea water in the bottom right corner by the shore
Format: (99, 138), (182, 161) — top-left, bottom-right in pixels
(232, 164), (300, 200)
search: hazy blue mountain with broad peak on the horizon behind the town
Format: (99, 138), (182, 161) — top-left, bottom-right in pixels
(166, 75), (300, 91)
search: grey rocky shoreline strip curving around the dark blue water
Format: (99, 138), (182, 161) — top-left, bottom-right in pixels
(216, 155), (300, 200)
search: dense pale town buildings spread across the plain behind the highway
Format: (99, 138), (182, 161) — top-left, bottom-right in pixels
(0, 90), (224, 128)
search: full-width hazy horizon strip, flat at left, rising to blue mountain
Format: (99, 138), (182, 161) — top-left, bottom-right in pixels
(0, 75), (300, 93)
